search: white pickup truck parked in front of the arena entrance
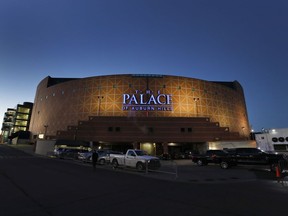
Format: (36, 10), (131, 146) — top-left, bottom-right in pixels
(110, 149), (161, 171)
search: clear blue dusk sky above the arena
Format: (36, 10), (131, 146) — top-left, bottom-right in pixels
(0, 0), (288, 131)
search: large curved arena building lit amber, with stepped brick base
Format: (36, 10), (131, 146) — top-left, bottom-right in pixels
(30, 74), (250, 155)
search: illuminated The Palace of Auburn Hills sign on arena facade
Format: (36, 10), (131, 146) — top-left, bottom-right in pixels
(122, 90), (173, 111)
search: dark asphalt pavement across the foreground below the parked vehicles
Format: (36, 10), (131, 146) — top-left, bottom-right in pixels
(0, 145), (288, 216)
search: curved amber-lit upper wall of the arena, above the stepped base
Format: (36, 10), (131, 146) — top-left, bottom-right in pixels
(30, 75), (250, 137)
